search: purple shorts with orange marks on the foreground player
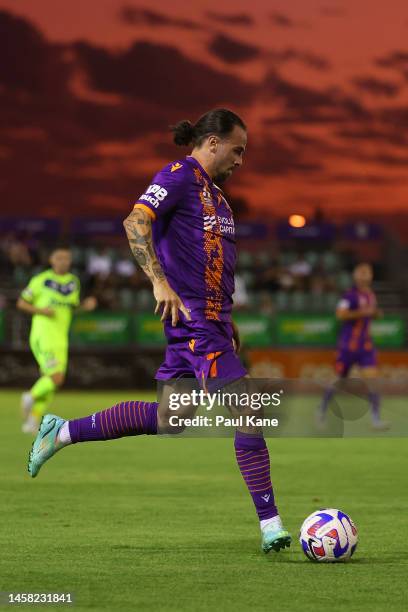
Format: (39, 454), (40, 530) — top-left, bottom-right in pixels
(156, 321), (247, 391)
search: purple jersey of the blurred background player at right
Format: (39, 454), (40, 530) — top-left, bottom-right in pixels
(338, 287), (377, 352)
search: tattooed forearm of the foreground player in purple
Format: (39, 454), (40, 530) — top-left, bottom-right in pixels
(123, 208), (166, 282)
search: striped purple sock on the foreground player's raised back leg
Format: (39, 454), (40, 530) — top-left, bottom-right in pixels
(68, 401), (159, 444)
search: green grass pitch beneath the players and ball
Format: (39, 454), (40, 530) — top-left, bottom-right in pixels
(0, 391), (408, 612)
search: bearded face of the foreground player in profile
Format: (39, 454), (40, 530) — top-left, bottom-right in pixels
(210, 125), (247, 183)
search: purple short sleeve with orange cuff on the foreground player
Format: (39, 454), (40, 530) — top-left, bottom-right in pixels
(134, 162), (188, 219)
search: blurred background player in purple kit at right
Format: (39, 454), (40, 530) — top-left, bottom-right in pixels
(318, 263), (389, 430)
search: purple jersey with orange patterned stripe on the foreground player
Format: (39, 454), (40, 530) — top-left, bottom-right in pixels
(135, 156), (236, 321)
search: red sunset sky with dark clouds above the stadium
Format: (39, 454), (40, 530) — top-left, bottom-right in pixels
(0, 0), (408, 216)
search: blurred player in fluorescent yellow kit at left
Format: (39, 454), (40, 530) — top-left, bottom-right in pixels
(17, 247), (96, 433)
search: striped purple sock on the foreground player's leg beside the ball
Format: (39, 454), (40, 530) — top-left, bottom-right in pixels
(235, 431), (278, 520)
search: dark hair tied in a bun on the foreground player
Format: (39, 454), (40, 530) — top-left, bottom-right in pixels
(170, 108), (246, 147)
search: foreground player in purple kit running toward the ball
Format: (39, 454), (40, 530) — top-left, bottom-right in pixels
(28, 109), (291, 552)
